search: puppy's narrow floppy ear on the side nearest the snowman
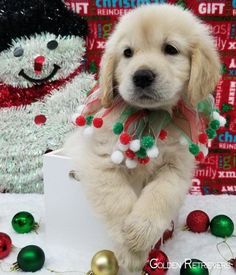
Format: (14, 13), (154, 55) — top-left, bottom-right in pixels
(99, 48), (115, 108)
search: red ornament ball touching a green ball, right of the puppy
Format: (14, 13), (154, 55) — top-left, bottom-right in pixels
(186, 210), (210, 233)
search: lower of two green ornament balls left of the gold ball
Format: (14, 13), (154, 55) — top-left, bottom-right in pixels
(17, 245), (45, 272)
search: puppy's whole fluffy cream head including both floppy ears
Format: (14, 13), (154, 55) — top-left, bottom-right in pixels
(100, 5), (219, 108)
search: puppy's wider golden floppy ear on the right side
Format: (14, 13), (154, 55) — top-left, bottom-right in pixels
(188, 30), (220, 107)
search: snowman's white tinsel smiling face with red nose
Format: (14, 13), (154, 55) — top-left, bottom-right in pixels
(0, 33), (85, 88)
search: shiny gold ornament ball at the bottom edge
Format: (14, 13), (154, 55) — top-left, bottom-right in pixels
(91, 250), (119, 275)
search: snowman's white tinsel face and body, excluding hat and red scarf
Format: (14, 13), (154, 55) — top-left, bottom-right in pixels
(0, 34), (94, 193)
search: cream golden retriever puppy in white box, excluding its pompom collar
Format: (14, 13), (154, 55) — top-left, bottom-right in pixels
(65, 4), (220, 270)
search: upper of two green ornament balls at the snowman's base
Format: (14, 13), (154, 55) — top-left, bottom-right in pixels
(11, 211), (38, 234)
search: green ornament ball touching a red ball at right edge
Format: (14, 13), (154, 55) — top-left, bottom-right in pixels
(210, 215), (234, 238)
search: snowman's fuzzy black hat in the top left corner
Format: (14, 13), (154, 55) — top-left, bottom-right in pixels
(0, 0), (87, 51)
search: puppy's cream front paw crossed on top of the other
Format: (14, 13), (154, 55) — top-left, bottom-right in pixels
(123, 213), (165, 252)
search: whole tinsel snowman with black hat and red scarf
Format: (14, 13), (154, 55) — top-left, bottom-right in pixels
(0, 0), (94, 193)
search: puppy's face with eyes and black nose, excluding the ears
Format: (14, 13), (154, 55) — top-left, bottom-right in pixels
(114, 20), (190, 108)
